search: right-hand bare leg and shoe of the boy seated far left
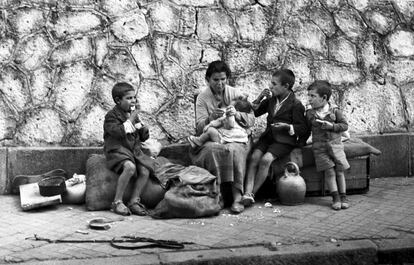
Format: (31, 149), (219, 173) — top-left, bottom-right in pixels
(128, 164), (150, 215)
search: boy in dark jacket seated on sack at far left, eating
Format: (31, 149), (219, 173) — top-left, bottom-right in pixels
(104, 83), (154, 215)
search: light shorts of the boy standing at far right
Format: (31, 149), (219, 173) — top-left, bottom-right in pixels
(312, 142), (350, 171)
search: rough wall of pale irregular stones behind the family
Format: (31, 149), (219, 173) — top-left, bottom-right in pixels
(0, 0), (414, 146)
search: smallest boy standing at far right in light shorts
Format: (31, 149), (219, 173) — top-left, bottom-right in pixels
(306, 80), (350, 210)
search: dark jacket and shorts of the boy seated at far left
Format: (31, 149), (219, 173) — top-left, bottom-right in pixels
(104, 105), (154, 171)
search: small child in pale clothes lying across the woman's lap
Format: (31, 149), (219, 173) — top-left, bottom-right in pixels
(188, 99), (252, 148)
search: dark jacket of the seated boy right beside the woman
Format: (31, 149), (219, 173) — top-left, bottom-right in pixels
(254, 92), (309, 146)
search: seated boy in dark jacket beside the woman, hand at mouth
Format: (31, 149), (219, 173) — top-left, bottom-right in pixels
(242, 69), (309, 206)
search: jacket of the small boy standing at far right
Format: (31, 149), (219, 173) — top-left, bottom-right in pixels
(306, 104), (348, 142)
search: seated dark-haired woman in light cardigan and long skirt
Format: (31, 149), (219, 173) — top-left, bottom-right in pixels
(192, 61), (254, 213)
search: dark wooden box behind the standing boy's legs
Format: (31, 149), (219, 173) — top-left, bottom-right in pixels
(300, 156), (369, 196)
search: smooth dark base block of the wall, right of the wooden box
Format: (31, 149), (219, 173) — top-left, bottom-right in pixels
(360, 134), (410, 178)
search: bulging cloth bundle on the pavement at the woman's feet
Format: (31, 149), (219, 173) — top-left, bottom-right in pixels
(149, 163), (221, 218)
